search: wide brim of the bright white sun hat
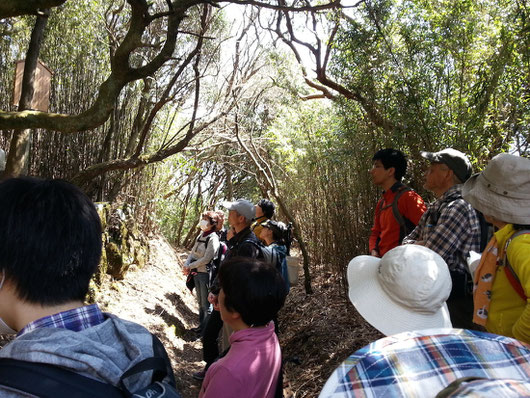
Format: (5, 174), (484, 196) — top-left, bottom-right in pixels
(348, 256), (452, 336)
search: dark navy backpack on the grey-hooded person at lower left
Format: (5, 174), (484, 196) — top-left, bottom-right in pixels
(0, 334), (180, 398)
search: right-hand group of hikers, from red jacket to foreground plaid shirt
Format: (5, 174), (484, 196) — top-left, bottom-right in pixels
(320, 148), (530, 398)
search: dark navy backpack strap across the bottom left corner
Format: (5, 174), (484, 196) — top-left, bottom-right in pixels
(0, 358), (123, 398)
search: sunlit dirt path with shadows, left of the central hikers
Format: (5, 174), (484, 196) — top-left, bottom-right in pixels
(97, 237), (203, 398)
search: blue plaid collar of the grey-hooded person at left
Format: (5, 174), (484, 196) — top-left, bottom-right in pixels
(17, 304), (105, 337)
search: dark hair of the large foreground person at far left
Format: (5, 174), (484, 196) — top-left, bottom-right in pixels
(0, 177), (101, 305)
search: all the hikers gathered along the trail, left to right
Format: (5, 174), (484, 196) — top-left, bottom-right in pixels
(0, 148), (530, 398)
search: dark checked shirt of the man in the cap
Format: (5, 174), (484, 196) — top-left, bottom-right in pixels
(403, 184), (480, 272)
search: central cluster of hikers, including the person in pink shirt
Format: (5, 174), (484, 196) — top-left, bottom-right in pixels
(183, 199), (290, 397)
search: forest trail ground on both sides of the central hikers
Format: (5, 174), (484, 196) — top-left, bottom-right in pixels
(97, 237), (381, 398)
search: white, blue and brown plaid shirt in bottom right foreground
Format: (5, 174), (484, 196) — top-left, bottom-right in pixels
(320, 329), (530, 398)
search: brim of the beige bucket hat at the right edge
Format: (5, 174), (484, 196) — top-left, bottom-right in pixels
(462, 173), (530, 225)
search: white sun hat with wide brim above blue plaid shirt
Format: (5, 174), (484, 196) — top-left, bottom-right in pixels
(348, 245), (452, 336)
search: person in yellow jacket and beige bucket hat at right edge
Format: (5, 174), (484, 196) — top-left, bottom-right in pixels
(462, 153), (530, 343)
